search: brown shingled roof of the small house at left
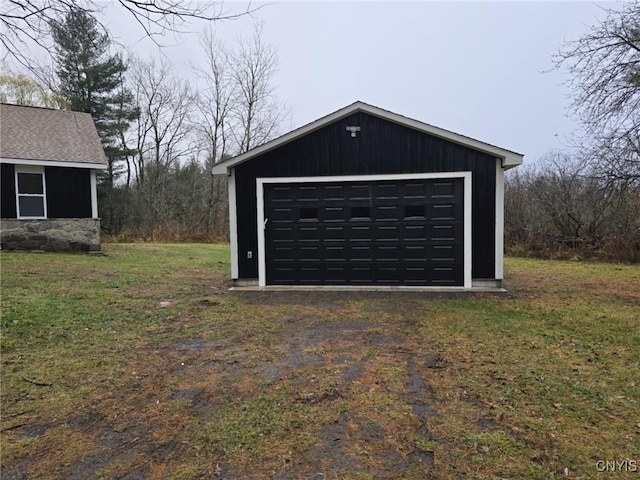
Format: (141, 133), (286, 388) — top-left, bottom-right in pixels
(0, 103), (107, 169)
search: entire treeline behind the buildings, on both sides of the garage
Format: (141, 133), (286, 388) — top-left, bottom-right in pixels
(0, 0), (640, 262)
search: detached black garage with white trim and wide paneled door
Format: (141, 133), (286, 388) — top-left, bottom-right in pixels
(213, 102), (523, 289)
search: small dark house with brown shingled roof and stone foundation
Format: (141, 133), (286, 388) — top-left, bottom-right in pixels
(0, 104), (107, 252)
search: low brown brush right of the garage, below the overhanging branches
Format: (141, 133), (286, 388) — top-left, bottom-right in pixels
(505, 153), (640, 262)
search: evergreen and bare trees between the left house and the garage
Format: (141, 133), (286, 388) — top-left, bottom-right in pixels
(0, 8), (288, 241)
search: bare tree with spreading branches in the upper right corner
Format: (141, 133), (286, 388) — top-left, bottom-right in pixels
(554, 0), (640, 181)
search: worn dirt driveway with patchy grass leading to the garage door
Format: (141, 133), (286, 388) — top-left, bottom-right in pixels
(2, 289), (480, 480)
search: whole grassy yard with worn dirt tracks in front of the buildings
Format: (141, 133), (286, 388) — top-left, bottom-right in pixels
(0, 244), (640, 480)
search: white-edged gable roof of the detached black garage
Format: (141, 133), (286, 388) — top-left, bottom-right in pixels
(212, 101), (524, 175)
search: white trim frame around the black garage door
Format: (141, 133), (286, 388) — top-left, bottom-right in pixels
(254, 172), (472, 288)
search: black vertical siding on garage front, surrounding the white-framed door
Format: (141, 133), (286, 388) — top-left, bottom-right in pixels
(235, 112), (497, 278)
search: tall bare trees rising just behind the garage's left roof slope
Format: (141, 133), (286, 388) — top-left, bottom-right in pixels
(188, 22), (286, 236)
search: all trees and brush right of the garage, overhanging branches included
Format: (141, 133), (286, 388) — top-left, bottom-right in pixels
(505, 0), (640, 262)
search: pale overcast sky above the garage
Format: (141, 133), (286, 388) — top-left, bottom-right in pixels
(105, 1), (617, 162)
